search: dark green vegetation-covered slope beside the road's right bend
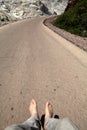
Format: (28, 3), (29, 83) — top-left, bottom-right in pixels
(53, 0), (87, 37)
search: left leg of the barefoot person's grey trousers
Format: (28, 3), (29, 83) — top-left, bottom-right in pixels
(5, 116), (41, 130)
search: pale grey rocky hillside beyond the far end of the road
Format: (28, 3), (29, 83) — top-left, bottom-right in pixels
(0, 0), (68, 25)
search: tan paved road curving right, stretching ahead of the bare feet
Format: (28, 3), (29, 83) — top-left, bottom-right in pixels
(0, 18), (87, 130)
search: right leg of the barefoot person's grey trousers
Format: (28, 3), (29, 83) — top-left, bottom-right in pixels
(45, 118), (78, 130)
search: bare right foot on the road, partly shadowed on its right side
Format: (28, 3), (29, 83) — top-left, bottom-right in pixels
(45, 102), (53, 120)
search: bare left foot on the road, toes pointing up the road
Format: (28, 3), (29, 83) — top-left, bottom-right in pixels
(29, 99), (38, 117)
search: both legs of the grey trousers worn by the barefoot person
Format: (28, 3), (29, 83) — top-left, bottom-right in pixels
(5, 116), (78, 130)
